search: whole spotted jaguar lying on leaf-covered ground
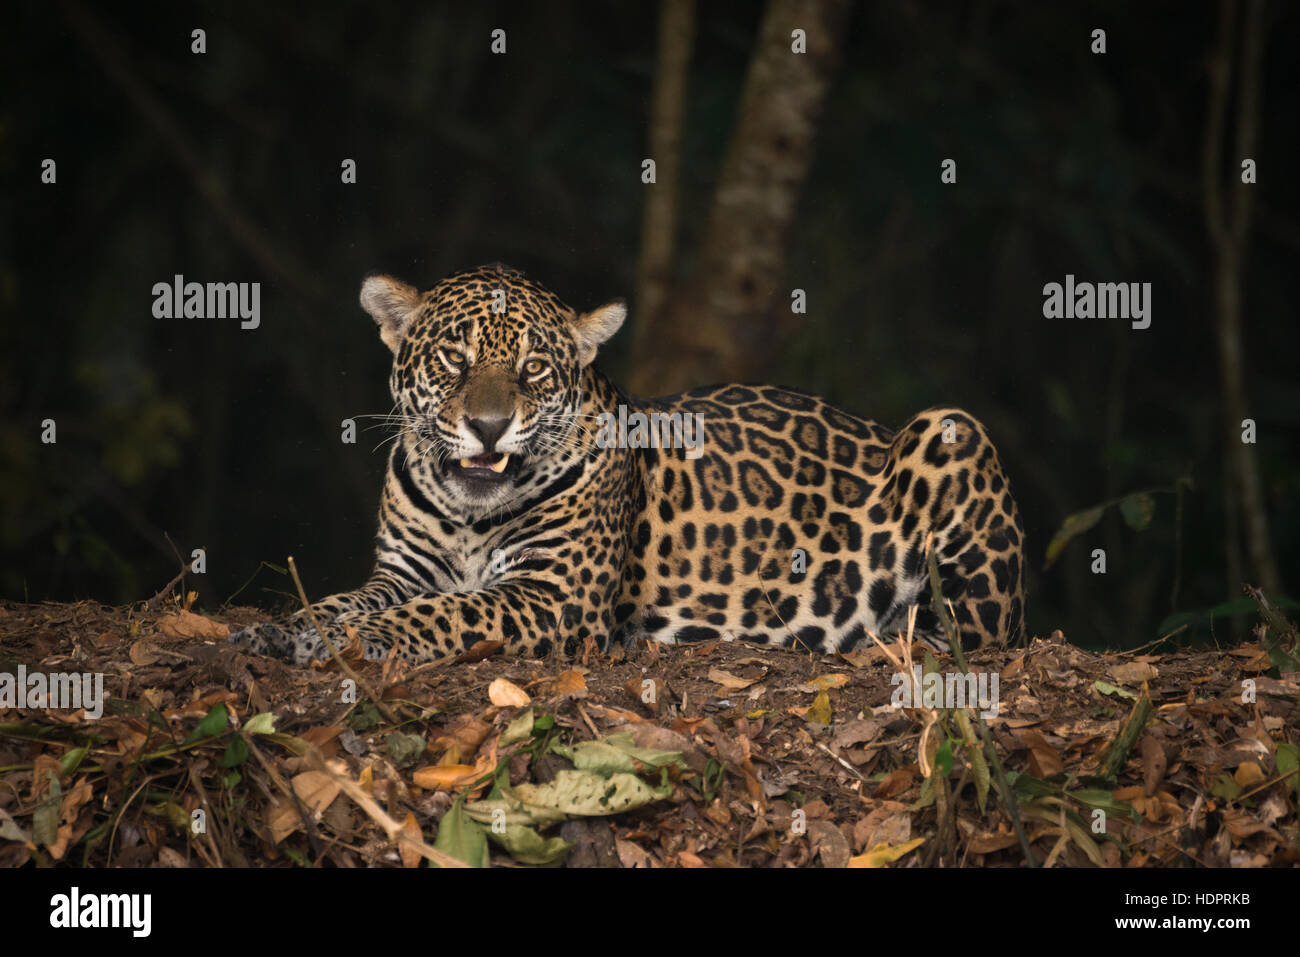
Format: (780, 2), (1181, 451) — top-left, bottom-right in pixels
(230, 264), (1024, 664)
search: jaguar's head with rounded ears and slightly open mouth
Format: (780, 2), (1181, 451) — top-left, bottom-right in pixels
(361, 265), (627, 506)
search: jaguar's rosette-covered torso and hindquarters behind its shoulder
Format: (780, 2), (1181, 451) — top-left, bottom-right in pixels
(623, 385), (1023, 650)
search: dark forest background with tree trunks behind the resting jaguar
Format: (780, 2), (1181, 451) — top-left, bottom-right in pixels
(0, 0), (1300, 648)
